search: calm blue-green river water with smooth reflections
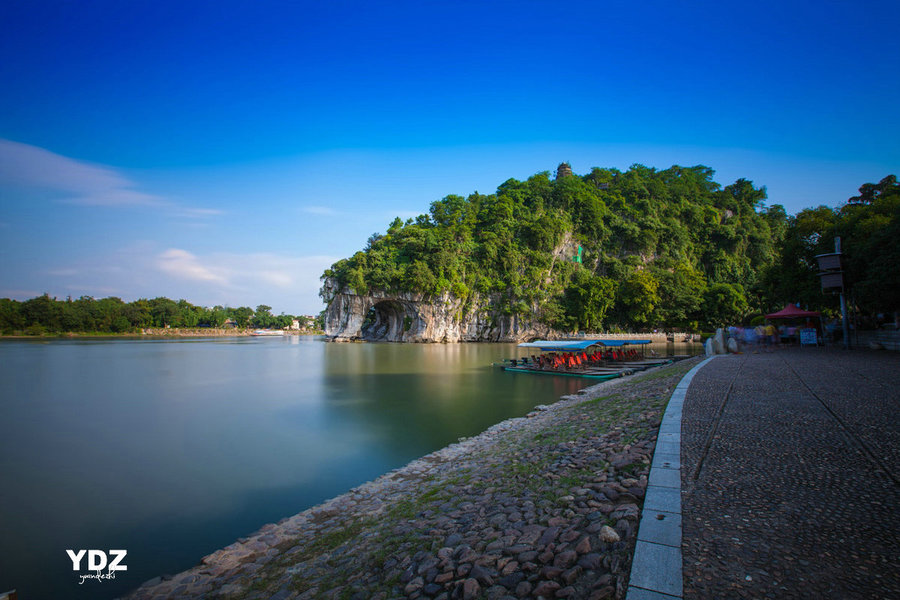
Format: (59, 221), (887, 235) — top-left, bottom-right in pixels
(0, 337), (595, 600)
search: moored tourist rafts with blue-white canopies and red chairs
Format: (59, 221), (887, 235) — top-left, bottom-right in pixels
(498, 340), (675, 380)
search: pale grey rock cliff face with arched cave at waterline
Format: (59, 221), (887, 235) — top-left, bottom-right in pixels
(322, 279), (558, 343)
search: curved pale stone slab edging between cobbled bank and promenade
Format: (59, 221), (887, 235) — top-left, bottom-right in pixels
(626, 356), (716, 600)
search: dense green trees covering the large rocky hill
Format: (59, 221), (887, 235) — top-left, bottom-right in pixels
(323, 165), (787, 330)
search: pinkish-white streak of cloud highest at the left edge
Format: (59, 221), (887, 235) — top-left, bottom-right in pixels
(0, 138), (222, 218)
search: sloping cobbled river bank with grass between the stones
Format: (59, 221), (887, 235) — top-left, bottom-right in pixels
(128, 359), (697, 600)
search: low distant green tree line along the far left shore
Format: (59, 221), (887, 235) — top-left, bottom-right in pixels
(0, 294), (320, 335)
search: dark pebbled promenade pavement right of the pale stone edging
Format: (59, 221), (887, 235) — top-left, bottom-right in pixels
(684, 348), (900, 599)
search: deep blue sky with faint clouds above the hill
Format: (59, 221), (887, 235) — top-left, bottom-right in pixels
(0, 0), (900, 314)
